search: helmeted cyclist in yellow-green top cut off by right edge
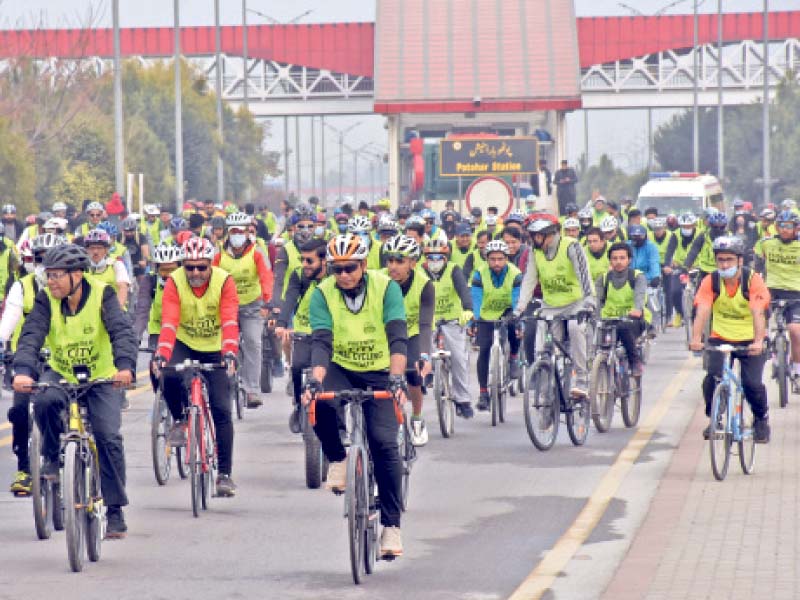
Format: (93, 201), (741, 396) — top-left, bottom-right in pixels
(761, 210), (800, 388)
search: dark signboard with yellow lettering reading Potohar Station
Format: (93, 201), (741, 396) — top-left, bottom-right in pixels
(439, 137), (539, 177)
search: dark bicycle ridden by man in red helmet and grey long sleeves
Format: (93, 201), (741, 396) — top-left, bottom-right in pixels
(523, 311), (591, 451)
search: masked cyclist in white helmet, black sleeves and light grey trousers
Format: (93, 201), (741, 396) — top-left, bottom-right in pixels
(422, 234), (474, 419)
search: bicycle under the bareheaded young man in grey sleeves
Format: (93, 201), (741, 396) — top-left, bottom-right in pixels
(589, 318), (646, 433)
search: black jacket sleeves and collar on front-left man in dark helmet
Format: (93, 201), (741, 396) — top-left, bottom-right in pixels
(14, 279), (139, 379)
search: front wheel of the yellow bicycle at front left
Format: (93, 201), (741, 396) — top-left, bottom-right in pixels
(61, 441), (86, 573)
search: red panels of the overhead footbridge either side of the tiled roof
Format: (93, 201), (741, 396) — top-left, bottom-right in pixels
(0, 10), (800, 77)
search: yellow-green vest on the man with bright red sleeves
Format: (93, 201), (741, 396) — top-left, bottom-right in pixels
(170, 267), (228, 352)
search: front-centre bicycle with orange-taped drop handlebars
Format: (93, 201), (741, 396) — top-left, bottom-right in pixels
(308, 390), (404, 584)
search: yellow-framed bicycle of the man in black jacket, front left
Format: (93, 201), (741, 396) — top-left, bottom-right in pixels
(31, 367), (113, 573)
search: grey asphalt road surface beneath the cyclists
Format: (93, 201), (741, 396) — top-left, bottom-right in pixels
(0, 332), (701, 600)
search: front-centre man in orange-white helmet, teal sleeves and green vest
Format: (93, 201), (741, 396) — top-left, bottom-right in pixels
(304, 234), (408, 556)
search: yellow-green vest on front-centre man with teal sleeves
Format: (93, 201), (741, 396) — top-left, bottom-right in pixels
(318, 271), (392, 372)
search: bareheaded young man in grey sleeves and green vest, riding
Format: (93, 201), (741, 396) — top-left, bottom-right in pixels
(595, 242), (650, 377)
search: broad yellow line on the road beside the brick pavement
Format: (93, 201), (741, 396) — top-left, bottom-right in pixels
(510, 356), (698, 600)
